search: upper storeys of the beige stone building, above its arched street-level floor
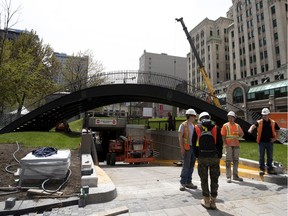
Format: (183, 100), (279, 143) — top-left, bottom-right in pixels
(188, 0), (287, 93)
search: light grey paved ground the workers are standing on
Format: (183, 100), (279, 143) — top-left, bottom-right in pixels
(0, 161), (288, 216)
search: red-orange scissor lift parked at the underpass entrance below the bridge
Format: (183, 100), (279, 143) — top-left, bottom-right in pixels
(106, 136), (155, 165)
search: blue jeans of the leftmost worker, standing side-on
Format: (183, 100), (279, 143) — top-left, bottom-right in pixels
(180, 146), (196, 184)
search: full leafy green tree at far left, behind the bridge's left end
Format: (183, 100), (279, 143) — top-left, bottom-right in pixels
(5, 31), (55, 114)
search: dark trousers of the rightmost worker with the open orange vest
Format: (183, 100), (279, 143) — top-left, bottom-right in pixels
(258, 142), (273, 171)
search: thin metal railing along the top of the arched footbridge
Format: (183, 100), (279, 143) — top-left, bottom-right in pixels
(0, 71), (261, 128)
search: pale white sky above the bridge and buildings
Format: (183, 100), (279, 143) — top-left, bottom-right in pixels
(6, 0), (232, 72)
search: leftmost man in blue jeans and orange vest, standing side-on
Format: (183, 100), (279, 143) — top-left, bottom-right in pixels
(178, 109), (197, 191)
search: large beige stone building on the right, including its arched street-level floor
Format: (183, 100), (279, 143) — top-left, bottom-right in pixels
(187, 0), (288, 115)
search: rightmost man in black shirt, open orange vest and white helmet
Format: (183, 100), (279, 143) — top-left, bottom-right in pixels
(248, 108), (280, 175)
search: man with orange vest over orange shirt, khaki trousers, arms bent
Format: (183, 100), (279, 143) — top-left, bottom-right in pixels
(221, 111), (244, 183)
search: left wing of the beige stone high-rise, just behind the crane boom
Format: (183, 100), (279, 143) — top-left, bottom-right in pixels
(187, 17), (233, 92)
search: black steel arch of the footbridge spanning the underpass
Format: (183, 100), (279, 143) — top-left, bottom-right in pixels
(0, 72), (255, 140)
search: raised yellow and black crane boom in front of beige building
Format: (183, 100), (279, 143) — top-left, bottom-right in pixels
(175, 17), (221, 108)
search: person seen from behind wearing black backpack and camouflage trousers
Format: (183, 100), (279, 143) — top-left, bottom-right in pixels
(192, 112), (223, 209)
